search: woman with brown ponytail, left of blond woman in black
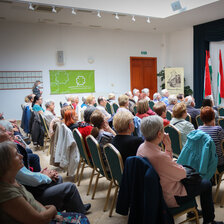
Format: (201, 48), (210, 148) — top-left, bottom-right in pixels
(90, 110), (116, 153)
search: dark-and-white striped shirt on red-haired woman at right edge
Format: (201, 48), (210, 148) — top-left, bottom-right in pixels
(198, 126), (224, 166)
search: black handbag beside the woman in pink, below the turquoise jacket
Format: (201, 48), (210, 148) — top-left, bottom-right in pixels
(180, 165), (202, 185)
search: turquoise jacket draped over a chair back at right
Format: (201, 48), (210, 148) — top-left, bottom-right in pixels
(177, 130), (218, 180)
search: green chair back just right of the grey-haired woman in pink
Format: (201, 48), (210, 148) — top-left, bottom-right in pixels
(164, 124), (182, 157)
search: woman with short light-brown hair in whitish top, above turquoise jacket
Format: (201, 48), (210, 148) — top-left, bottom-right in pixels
(170, 103), (194, 146)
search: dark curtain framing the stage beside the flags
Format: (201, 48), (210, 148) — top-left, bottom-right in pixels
(194, 19), (224, 107)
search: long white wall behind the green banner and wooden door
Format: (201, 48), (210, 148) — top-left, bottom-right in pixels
(0, 22), (164, 119)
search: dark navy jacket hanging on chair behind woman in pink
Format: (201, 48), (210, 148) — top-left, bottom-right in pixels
(116, 156), (174, 224)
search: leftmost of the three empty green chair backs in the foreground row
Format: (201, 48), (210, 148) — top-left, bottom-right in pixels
(73, 128), (93, 167)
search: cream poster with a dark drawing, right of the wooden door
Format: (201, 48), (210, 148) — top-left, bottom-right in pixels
(165, 68), (184, 95)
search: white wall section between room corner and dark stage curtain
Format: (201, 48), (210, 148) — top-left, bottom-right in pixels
(165, 27), (193, 90)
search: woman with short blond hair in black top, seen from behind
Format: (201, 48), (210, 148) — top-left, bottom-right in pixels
(112, 110), (143, 162)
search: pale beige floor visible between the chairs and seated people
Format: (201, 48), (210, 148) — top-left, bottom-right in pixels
(33, 144), (224, 224)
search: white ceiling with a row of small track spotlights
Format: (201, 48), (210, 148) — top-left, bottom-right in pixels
(0, 0), (224, 33)
